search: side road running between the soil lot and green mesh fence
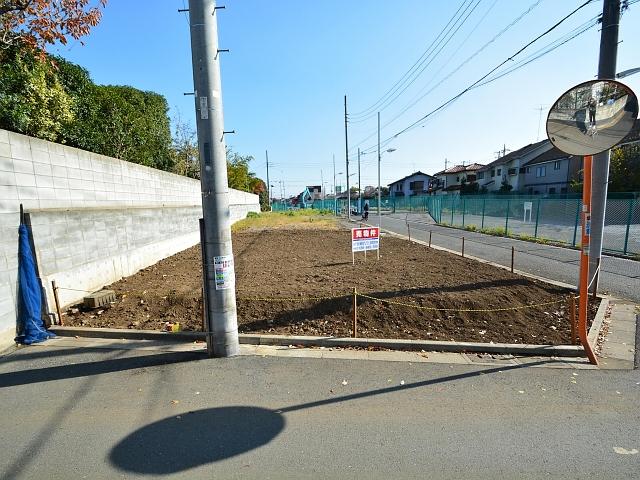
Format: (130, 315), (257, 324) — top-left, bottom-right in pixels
(378, 214), (640, 302)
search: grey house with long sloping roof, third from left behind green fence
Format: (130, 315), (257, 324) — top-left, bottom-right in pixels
(476, 139), (553, 192)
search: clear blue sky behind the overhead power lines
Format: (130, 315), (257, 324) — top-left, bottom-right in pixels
(55, 0), (640, 194)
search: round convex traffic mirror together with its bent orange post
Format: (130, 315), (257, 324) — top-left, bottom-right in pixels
(547, 80), (638, 364)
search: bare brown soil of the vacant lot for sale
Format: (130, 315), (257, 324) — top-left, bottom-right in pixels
(65, 225), (597, 344)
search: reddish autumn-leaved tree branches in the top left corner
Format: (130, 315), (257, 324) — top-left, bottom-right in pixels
(0, 0), (107, 54)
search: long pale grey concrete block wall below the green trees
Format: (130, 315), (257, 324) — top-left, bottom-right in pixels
(0, 130), (260, 350)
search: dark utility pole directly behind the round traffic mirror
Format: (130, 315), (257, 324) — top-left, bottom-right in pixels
(589, 0), (620, 292)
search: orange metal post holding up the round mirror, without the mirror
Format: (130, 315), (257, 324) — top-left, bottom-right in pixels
(578, 155), (598, 365)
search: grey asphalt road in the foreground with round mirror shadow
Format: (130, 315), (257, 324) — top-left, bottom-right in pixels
(0, 346), (640, 480)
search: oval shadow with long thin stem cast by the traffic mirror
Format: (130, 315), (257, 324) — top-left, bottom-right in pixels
(109, 360), (550, 475)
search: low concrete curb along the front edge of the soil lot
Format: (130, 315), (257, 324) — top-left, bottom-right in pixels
(50, 326), (584, 357)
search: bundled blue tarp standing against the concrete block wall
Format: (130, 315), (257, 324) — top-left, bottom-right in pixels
(16, 224), (55, 345)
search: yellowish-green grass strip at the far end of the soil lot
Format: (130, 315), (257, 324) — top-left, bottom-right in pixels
(231, 209), (337, 232)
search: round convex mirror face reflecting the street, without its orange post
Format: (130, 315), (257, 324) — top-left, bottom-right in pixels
(547, 80), (638, 156)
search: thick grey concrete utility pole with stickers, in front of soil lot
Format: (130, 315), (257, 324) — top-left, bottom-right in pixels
(189, 0), (240, 357)
